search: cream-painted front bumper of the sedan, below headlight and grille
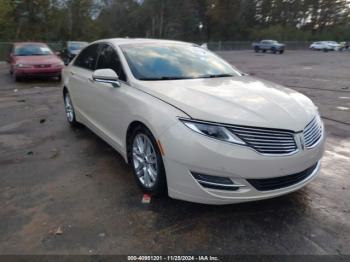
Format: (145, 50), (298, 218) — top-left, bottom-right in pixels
(160, 123), (325, 204)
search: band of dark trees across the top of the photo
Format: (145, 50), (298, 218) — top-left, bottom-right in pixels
(0, 0), (350, 42)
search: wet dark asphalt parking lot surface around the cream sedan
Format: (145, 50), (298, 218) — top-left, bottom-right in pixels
(0, 51), (350, 255)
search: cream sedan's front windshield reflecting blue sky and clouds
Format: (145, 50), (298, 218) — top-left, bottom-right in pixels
(121, 44), (241, 80)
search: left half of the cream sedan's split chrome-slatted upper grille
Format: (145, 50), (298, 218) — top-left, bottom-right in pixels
(228, 126), (298, 155)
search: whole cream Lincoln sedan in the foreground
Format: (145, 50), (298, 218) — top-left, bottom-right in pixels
(63, 39), (325, 204)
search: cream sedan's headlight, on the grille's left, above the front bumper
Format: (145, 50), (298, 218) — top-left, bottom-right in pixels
(180, 118), (245, 145)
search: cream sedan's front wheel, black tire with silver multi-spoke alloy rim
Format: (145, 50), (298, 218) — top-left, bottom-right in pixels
(128, 125), (167, 196)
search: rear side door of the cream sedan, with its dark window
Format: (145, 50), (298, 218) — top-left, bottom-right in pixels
(68, 44), (100, 125)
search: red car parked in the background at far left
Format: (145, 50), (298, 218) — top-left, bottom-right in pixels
(9, 42), (64, 81)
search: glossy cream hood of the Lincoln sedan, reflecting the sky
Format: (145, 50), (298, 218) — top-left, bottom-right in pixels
(139, 76), (317, 131)
